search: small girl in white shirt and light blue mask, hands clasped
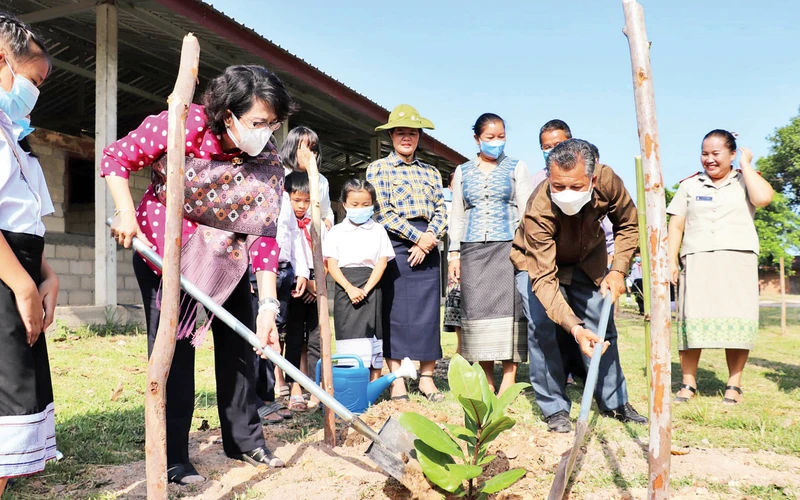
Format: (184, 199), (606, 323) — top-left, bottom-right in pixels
(322, 179), (394, 380)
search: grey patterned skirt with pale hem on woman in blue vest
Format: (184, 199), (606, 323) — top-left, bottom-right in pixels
(461, 241), (528, 363)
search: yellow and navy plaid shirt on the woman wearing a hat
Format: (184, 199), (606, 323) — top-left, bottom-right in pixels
(367, 151), (447, 243)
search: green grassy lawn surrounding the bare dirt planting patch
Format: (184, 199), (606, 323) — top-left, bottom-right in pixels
(4, 308), (800, 499)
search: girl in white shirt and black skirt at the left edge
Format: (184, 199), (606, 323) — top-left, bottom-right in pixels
(0, 13), (58, 496)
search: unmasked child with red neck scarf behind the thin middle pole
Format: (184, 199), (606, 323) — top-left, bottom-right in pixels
(284, 171), (324, 411)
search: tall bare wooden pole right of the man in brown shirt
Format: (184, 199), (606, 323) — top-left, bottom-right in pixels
(622, 0), (672, 500)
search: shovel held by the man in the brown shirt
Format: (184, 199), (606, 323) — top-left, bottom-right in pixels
(547, 291), (614, 500)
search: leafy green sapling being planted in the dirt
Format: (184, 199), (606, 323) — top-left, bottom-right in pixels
(399, 354), (529, 499)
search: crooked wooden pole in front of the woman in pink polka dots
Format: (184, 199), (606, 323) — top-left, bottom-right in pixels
(144, 33), (200, 500)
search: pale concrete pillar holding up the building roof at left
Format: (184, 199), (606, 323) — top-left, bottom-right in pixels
(94, 3), (117, 306)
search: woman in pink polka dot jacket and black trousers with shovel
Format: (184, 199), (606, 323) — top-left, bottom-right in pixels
(101, 66), (296, 484)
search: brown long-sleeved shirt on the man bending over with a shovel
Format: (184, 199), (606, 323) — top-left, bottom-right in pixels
(511, 165), (639, 332)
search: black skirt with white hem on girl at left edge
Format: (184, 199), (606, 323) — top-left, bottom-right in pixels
(0, 231), (56, 478)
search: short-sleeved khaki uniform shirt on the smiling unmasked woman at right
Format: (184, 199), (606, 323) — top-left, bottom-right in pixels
(667, 171), (759, 257)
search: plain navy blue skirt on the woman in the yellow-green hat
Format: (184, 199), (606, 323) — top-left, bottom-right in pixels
(381, 219), (442, 361)
